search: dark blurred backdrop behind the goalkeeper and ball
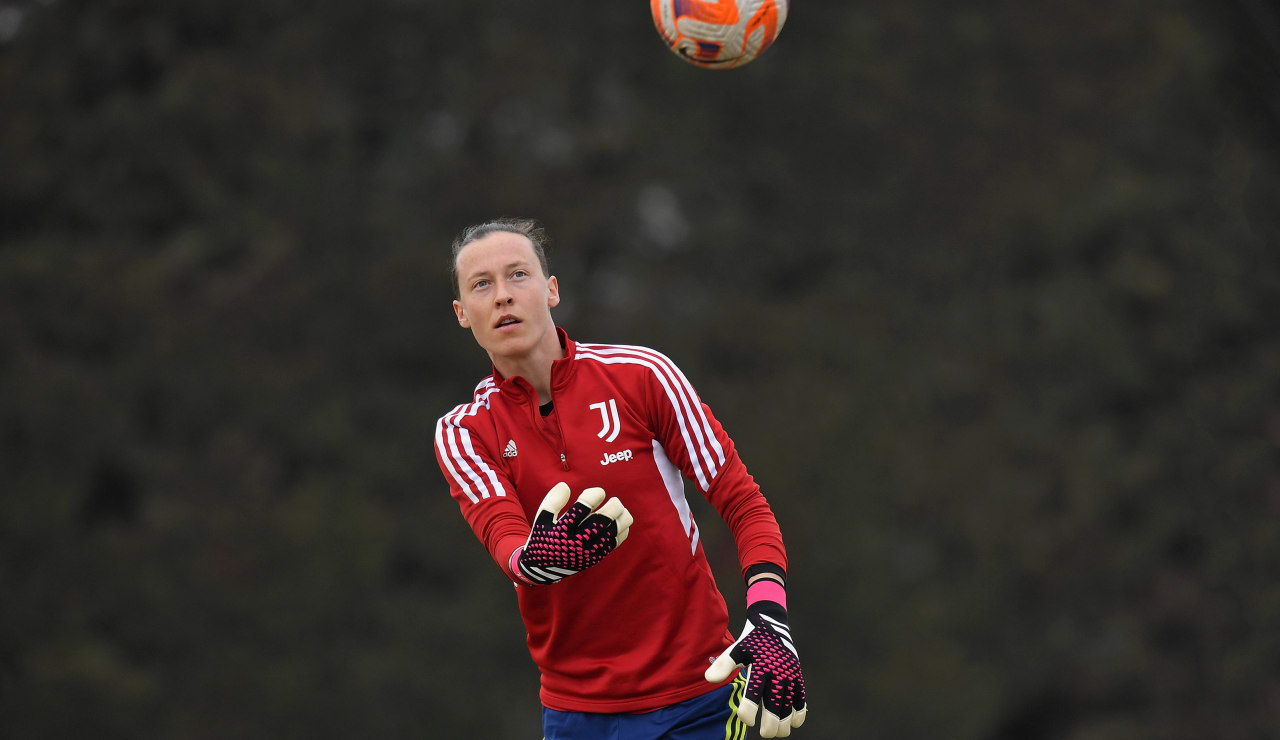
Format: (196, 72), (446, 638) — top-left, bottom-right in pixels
(0, 0), (1280, 740)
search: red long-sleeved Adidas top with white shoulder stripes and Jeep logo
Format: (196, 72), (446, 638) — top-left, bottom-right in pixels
(435, 329), (786, 712)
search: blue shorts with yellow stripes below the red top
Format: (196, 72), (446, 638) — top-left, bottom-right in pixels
(543, 676), (746, 740)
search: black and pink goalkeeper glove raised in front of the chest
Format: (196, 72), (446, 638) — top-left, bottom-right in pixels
(509, 483), (632, 586)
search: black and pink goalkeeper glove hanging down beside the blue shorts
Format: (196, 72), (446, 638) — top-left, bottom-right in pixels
(707, 579), (809, 737)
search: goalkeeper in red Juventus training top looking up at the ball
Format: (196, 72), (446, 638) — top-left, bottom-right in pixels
(435, 219), (808, 740)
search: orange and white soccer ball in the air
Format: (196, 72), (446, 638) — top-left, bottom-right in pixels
(649, 0), (790, 69)
